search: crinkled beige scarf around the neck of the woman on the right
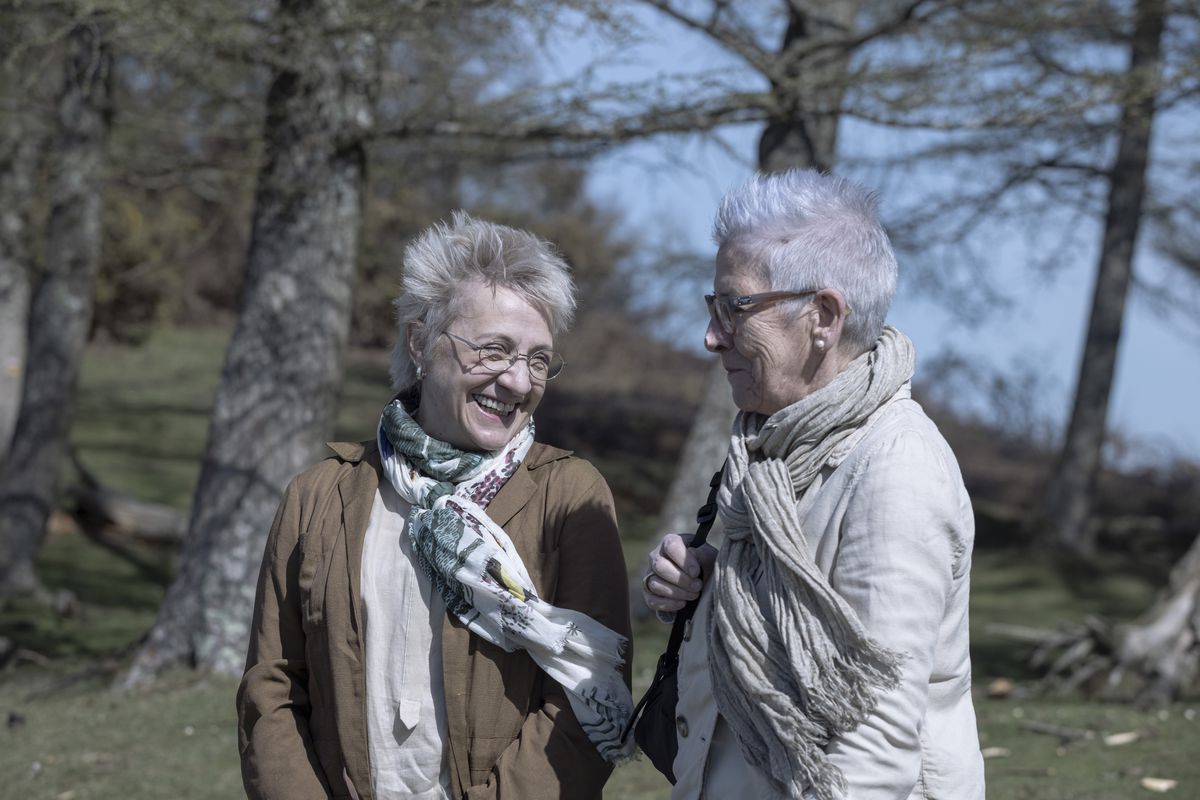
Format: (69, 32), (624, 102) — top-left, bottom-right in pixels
(708, 327), (913, 800)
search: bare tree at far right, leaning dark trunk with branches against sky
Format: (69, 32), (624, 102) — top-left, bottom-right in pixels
(856, 0), (1200, 563)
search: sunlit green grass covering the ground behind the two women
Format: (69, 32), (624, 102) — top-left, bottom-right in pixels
(0, 331), (1200, 800)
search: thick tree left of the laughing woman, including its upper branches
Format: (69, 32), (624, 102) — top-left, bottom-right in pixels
(119, 0), (643, 687)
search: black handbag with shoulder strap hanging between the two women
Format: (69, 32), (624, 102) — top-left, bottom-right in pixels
(623, 468), (724, 784)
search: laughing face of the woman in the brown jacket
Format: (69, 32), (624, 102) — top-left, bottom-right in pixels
(409, 282), (554, 451)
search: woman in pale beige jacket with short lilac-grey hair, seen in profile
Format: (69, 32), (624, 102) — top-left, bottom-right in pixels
(643, 170), (984, 800)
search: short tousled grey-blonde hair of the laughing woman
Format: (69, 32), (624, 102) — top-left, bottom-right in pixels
(390, 211), (575, 391)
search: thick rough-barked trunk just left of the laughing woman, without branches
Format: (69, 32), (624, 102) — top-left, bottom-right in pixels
(120, 0), (378, 687)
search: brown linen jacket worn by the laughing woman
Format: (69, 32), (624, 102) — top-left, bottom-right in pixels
(231, 443), (632, 800)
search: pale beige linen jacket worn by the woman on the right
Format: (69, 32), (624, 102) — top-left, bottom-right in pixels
(671, 384), (984, 800)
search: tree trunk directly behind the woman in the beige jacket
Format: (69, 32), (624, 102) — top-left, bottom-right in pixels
(630, 0), (859, 618)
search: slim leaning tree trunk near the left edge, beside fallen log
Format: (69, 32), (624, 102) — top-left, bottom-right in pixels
(0, 17), (112, 594)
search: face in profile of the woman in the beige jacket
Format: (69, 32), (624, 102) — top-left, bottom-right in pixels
(704, 240), (823, 416)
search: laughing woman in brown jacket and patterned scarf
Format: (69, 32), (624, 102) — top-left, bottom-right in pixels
(238, 215), (631, 800)
